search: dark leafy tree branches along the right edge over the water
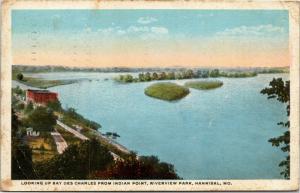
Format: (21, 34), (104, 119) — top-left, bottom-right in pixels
(261, 78), (290, 179)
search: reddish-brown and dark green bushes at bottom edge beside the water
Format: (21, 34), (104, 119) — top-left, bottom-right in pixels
(92, 154), (179, 179)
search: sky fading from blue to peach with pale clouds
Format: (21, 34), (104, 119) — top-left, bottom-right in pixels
(12, 9), (290, 67)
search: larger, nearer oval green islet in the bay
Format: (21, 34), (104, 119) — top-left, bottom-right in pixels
(145, 82), (189, 101)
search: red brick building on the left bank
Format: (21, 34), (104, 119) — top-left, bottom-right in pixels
(26, 89), (58, 105)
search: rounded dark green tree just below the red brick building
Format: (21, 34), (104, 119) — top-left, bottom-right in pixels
(28, 107), (57, 131)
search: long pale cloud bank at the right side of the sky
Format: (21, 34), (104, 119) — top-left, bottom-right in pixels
(216, 24), (284, 36)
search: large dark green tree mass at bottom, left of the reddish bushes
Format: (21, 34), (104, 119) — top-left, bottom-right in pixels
(36, 139), (113, 179)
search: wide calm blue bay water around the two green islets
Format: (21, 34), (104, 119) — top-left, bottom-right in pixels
(26, 73), (288, 179)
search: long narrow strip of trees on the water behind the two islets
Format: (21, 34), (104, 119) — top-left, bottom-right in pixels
(115, 69), (257, 83)
